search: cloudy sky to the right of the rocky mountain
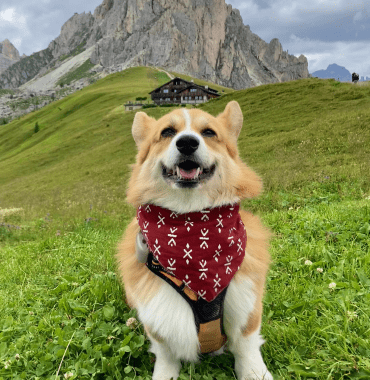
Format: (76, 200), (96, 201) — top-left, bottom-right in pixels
(226, 0), (370, 76)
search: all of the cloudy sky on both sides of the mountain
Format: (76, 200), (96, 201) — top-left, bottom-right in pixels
(0, 0), (370, 77)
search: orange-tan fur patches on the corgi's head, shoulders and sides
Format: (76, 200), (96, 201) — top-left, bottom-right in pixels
(117, 102), (270, 348)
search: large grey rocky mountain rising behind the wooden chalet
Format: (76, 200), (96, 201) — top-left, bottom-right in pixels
(0, 0), (309, 89)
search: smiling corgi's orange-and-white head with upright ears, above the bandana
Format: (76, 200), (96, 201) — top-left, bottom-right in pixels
(127, 101), (262, 213)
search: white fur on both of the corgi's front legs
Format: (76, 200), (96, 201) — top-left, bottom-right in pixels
(137, 277), (273, 380)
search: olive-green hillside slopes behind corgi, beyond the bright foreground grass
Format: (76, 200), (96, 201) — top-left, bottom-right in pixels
(0, 68), (370, 217)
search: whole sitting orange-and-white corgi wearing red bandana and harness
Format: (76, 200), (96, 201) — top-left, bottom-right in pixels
(117, 101), (273, 380)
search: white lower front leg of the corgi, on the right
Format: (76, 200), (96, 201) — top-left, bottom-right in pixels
(230, 328), (273, 380)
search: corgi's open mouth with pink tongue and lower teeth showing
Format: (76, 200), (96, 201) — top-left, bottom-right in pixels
(162, 160), (216, 187)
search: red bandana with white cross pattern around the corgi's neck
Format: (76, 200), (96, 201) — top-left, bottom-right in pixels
(137, 204), (247, 302)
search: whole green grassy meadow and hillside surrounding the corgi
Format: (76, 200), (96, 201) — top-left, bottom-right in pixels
(0, 67), (370, 380)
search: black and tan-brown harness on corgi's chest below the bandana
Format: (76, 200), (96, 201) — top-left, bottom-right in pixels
(147, 252), (227, 353)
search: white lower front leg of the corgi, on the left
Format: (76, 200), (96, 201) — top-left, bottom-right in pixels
(149, 337), (181, 380)
